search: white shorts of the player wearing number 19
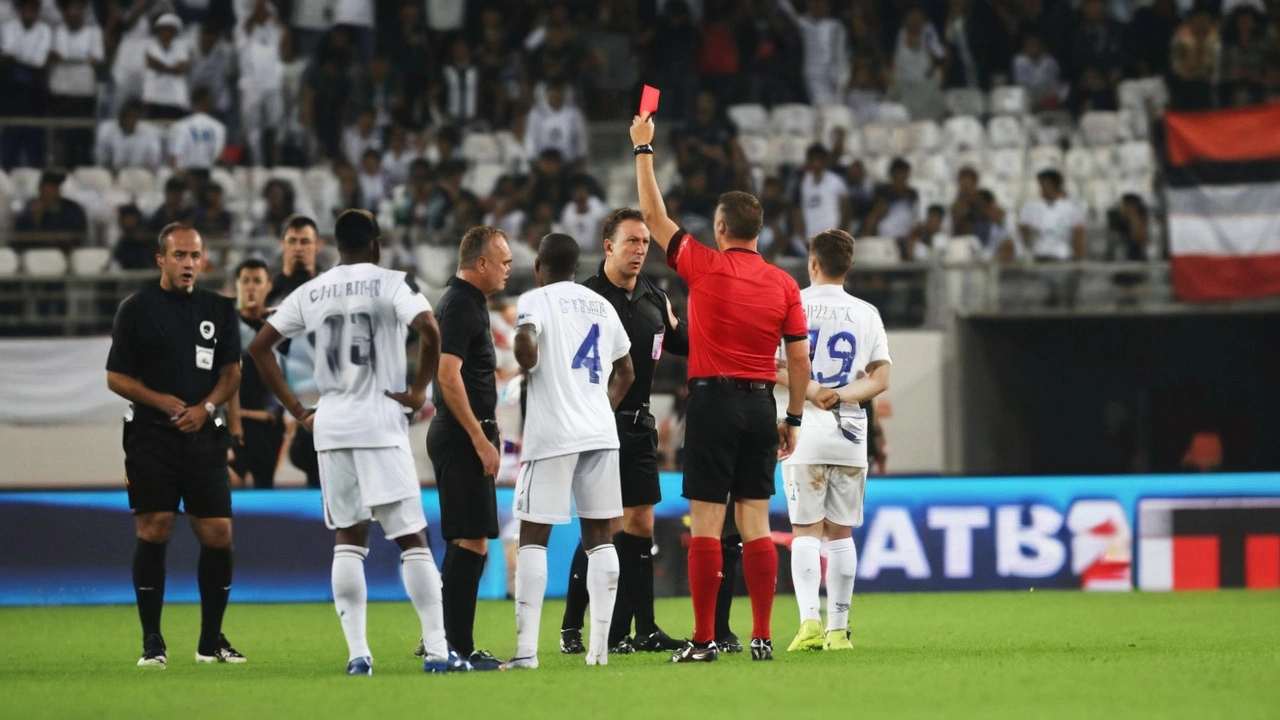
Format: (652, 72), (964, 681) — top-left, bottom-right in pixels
(782, 465), (867, 528)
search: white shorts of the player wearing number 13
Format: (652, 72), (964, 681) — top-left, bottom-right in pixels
(316, 447), (426, 539)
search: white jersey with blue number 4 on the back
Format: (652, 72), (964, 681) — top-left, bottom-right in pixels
(516, 282), (631, 462)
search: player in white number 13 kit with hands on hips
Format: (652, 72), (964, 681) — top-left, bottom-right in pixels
(248, 210), (470, 675)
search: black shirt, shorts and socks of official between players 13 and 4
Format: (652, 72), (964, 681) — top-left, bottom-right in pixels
(426, 277), (498, 657)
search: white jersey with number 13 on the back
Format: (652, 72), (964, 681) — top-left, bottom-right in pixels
(268, 263), (431, 451)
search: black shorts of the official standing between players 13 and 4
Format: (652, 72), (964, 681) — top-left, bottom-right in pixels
(426, 416), (500, 541)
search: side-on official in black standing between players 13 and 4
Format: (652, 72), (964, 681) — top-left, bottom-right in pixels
(426, 225), (511, 670)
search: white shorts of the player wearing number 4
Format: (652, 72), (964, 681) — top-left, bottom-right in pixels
(513, 450), (622, 525)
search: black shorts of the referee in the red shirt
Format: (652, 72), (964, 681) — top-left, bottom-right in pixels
(682, 378), (778, 503)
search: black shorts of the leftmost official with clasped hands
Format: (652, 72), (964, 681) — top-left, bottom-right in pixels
(124, 420), (232, 518)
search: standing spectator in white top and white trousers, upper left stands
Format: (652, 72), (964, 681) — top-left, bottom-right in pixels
(236, 0), (284, 165)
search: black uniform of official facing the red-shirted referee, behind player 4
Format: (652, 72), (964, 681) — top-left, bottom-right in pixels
(561, 263), (689, 650)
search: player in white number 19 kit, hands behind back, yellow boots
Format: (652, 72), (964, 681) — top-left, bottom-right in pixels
(778, 229), (891, 651)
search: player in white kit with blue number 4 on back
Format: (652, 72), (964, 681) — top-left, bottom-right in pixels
(506, 233), (635, 669)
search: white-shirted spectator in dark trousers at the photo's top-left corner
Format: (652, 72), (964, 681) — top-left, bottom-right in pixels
(0, 0), (54, 170)
